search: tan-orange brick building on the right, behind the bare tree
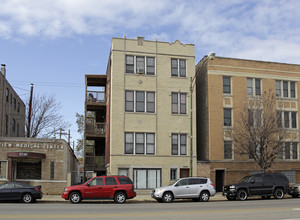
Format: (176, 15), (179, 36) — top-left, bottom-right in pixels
(196, 57), (300, 191)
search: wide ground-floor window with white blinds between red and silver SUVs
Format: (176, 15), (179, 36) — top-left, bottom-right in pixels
(133, 169), (161, 189)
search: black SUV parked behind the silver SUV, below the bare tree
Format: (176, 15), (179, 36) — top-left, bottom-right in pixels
(223, 173), (289, 200)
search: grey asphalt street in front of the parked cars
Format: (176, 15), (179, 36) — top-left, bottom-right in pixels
(0, 198), (300, 220)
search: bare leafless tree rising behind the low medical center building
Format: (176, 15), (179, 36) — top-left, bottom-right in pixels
(25, 94), (70, 138)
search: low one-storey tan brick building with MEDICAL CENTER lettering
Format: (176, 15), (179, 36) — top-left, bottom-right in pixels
(0, 137), (80, 194)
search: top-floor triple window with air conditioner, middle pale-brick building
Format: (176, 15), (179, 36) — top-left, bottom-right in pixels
(125, 55), (155, 75)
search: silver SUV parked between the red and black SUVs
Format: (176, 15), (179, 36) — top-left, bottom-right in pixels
(151, 177), (216, 202)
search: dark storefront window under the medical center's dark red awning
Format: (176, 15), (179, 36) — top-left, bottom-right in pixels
(17, 162), (42, 180)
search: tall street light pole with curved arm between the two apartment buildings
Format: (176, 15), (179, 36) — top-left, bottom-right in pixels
(190, 53), (216, 177)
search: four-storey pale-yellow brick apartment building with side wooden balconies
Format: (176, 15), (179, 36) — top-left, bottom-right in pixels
(85, 37), (197, 189)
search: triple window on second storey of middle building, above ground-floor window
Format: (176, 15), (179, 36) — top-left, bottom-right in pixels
(125, 132), (155, 154)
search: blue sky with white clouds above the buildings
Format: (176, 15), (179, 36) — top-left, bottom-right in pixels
(0, 0), (300, 146)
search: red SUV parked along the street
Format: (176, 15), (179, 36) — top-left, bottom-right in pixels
(62, 176), (136, 203)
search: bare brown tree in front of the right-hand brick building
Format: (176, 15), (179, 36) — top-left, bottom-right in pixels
(231, 90), (286, 172)
